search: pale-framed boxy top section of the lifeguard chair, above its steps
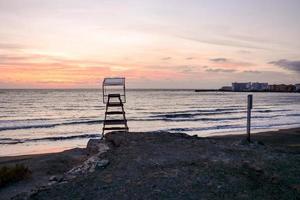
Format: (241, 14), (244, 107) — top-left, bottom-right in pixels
(102, 77), (126, 103)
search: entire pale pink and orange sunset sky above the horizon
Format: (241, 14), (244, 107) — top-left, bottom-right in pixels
(0, 0), (300, 88)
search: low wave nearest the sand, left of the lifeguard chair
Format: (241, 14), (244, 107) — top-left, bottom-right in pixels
(0, 134), (100, 144)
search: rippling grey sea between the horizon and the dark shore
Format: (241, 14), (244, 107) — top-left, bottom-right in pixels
(0, 89), (300, 156)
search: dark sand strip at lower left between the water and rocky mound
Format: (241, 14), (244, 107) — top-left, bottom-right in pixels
(0, 149), (87, 200)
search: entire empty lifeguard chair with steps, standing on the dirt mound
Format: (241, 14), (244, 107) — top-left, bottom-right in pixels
(102, 78), (128, 137)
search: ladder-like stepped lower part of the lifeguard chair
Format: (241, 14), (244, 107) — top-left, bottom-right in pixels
(102, 94), (129, 138)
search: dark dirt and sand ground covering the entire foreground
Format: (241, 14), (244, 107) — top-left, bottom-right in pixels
(0, 128), (300, 199)
